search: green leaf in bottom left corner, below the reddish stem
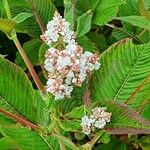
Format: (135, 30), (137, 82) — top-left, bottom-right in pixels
(0, 126), (52, 150)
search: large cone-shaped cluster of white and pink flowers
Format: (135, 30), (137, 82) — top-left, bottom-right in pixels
(41, 12), (100, 100)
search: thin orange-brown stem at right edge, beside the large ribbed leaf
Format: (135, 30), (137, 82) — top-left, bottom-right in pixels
(125, 75), (150, 104)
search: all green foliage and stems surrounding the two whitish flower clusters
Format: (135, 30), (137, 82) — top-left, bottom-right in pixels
(0, 0), (150, 150)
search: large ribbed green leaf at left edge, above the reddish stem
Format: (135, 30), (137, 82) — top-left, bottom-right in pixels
(0, 57), (36, 122)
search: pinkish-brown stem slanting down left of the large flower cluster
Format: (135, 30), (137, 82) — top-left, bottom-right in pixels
(13, 36), (44, 92)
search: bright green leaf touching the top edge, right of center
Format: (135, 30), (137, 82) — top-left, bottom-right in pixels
(93, 0), (125, 26)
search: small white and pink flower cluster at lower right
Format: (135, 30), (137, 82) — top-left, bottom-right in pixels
(81, 107), (111, 135)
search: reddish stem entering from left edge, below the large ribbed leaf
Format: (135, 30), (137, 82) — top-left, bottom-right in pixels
(0, 108), (41, 131)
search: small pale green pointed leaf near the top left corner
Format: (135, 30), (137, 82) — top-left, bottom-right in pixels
(13, 13), (33, 23)
